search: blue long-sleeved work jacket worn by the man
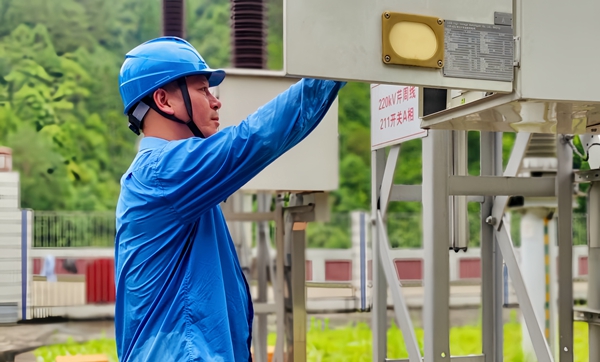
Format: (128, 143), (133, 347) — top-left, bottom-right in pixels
(115, 79), (344, 362)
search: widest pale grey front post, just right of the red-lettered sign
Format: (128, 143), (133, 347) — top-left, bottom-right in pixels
(423, 130), (450, 362)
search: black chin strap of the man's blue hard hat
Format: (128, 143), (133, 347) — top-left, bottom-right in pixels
(129, 78), (204, 138)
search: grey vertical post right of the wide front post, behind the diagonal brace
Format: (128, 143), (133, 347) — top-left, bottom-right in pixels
(480, 132), (503, 362)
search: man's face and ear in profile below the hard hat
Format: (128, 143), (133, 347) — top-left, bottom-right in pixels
(169, 75), (221, 137)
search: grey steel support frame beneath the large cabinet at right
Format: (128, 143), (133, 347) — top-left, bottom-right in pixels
(372, 130), (572, 362)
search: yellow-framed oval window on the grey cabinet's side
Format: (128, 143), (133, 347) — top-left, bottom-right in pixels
(382, 11), (444, 68)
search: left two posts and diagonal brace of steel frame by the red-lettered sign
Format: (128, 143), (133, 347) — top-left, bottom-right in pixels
(372, 131), (450, 362)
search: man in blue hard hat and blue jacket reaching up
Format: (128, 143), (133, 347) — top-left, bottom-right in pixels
(115, 37), (343, 362)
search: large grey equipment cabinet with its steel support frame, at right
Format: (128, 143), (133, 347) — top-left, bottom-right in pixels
(284, 0), (600, 362)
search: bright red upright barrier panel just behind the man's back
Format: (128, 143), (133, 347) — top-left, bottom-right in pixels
(85, 259), (115, 304)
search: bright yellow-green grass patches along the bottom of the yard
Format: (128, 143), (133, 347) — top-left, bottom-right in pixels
(34, 318), (588, 362)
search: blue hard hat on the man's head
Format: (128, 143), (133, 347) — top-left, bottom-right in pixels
(119, 36), (225, 114)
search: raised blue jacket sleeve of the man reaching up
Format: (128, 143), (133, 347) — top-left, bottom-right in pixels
(156, 79), (345, 222)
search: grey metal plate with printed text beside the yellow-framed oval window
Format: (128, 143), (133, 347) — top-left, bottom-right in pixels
(443, 20), (514, 82)
